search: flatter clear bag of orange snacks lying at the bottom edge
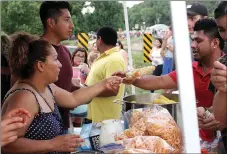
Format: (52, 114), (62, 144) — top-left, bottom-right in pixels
(116, 136), (174, 154)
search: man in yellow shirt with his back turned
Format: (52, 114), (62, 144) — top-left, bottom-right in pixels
(85, 27), (126, 123)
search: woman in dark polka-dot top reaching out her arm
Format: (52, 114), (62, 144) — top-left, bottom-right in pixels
(2, 34), (121, 154)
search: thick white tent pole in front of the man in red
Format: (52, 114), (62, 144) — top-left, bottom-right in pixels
(170, 1), (200, 153)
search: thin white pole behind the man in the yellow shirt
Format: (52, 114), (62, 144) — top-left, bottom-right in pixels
(123, 1), (136, 95)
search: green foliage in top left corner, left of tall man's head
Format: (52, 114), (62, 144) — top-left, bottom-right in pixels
(1, 1), (42, 34)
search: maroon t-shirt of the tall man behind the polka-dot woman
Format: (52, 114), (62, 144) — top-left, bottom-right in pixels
(53, 45), (73, 128)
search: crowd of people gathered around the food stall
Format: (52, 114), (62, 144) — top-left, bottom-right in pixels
(1, 1), (227, 154)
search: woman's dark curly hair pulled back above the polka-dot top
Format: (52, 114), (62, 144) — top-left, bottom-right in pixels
(9, 33), (51, 79)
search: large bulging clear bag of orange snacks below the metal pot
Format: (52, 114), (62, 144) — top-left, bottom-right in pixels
(121, 105), (183, 153)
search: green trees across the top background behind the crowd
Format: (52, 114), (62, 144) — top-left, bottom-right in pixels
(1, 1), (218, 35)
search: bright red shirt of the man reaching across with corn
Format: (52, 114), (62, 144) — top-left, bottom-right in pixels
(169, 62), (214, 141)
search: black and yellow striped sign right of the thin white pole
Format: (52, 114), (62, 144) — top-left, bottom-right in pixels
(143, 34), (152, 63)
